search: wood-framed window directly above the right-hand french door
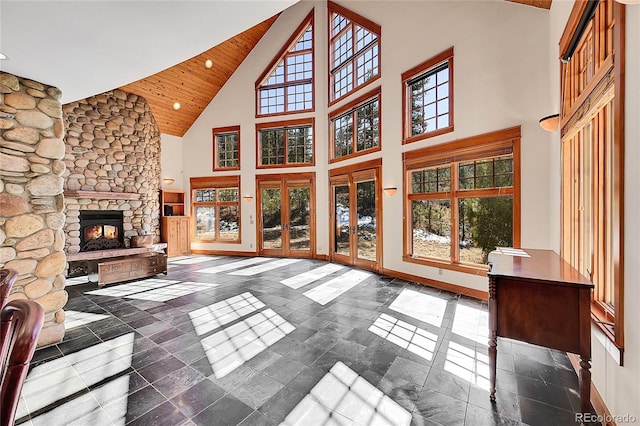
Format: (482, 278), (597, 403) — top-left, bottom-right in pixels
(329, 88), (381, 161)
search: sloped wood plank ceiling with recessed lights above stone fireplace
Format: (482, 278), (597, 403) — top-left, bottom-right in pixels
(120, 15), (278, 136)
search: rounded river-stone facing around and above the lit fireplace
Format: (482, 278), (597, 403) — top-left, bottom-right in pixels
(62, 90), (160, 253)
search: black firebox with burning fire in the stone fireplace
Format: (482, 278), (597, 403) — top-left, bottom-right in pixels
(80, 210), (124, 251)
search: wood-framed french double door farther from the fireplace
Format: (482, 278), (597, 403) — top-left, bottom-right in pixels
(330, 163), (382, 271)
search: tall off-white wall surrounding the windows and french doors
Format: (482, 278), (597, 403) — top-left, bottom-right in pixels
(183, 1), (558, 290)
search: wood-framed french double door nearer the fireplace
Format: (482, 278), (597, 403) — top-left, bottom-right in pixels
(256, 173), (315, 257)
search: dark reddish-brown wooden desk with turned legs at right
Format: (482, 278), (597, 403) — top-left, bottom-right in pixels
(488, 249), (593, 413)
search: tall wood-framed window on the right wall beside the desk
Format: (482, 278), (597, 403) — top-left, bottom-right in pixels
(560, 0), (625, 356)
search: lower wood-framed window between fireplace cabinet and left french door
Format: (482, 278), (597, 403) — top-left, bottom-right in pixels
(191, 176), (240, 243)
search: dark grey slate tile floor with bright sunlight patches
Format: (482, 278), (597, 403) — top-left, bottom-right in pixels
(17, 256), (596, 426)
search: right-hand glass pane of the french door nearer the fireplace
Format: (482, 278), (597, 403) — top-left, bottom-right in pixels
(288, 187), (311, 250)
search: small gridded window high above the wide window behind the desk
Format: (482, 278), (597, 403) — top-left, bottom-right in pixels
(402, 47), (453, 143)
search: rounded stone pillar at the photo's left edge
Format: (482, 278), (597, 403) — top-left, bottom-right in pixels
(0, 73), (67, 346)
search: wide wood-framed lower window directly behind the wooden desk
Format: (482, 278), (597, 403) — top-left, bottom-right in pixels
(404, 127), (520, 272)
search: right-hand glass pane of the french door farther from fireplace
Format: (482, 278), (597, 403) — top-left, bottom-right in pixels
(356, 180), (377, 262)
